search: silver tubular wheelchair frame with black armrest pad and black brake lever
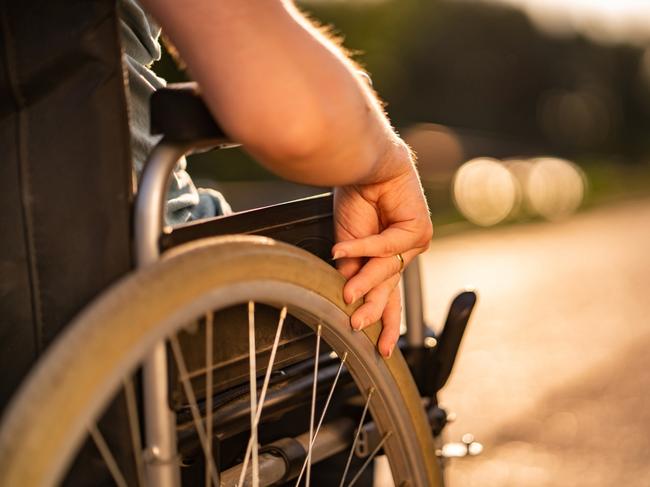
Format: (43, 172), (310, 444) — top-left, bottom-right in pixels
(130, 83), (476, 487)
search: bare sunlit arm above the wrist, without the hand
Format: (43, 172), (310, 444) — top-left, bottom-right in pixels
(143, 0), (404, 186)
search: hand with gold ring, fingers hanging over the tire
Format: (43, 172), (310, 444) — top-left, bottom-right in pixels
(332, 143), (433, 357)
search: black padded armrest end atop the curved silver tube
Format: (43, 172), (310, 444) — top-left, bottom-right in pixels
(150, 83), (226, 142)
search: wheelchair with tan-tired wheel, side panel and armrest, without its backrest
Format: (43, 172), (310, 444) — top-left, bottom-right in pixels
(0, 3), (476, 487)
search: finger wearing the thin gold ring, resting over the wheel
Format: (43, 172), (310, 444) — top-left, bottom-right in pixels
(343, 251), (418, 303)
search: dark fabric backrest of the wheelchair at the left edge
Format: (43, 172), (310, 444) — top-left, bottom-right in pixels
(0, 0), (134, 486)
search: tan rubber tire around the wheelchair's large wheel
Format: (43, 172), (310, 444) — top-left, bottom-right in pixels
(0, 236), (440, 487)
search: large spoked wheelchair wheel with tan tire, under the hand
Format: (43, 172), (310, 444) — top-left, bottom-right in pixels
(0, 236), (441, 487)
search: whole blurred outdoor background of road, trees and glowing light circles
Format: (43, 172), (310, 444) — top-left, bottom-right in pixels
(155, 0), (650, 487)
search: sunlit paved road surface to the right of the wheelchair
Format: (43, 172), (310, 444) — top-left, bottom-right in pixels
(423, 200), (650, 487)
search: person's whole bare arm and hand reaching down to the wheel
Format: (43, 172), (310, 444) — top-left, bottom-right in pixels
(141, 0), (432, 357)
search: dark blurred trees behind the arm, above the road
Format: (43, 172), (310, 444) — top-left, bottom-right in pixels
(149, 0), (650, 189)
